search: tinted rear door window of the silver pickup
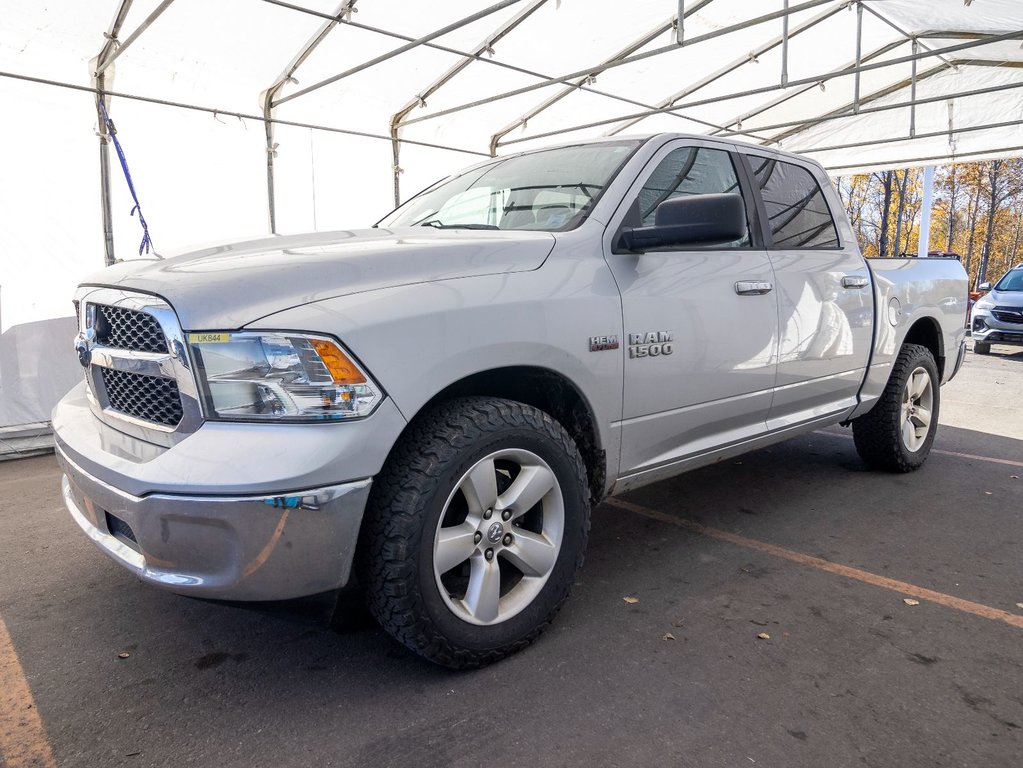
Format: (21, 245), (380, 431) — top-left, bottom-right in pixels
(750, 156), (839, 249)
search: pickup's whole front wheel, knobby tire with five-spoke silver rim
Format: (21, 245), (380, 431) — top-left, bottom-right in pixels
(359, 398), (589, 669)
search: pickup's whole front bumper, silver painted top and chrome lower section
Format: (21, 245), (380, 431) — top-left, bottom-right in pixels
(53, 378), (406, 600)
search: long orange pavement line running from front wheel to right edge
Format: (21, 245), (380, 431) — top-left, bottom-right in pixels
(606, 498), (1023, 629)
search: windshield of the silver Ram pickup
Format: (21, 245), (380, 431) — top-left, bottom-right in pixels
(376, 141), (639, 232)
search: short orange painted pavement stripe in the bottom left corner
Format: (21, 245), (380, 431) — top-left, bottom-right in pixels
(0, 619), (56, 768)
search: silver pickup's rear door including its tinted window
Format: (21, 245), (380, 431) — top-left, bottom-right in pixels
(744, 150), (874, 430)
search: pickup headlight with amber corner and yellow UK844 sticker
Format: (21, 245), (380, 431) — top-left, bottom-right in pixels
(188, 331), (383, 421)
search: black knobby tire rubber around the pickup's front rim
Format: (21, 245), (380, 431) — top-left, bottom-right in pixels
(359, 397), (589, 669)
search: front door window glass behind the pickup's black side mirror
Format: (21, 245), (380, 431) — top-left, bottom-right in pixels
(639, 146), (750, 249)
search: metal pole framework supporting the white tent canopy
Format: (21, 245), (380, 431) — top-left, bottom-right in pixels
(0, 0), (1023, 263)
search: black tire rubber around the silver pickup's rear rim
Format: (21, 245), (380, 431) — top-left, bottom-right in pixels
(852, 344), (940, 472)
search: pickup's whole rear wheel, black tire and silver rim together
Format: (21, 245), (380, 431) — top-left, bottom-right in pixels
(852, 344), (939, 472)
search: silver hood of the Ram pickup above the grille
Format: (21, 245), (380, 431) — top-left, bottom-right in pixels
(83, 227), (554, 330)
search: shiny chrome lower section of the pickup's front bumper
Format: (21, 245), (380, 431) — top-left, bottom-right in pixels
(57, 450), (370, 600)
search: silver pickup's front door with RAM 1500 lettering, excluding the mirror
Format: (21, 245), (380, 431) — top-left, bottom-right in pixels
(606, 139), (777, 476)
